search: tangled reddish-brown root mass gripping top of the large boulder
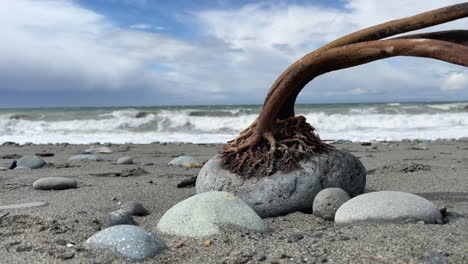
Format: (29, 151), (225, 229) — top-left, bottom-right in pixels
(221, 116), (332, 177)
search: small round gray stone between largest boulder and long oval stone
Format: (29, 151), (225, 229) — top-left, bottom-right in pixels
(312, 188), (351, 220)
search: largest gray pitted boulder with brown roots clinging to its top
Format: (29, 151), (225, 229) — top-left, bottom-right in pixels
(196, 150), (366, 217)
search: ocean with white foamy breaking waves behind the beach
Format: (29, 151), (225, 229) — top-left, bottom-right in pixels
(0, 102), (468, 144)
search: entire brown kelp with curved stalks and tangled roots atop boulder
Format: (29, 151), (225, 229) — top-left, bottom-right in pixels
(220, 2), (468, 178)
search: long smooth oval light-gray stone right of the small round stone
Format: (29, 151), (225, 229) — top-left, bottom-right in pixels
(335, 191), (442, 225)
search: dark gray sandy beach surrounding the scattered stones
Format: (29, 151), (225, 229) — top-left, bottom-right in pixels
(0, 139), (468, 263)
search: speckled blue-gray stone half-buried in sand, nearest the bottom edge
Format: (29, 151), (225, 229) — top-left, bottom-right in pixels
(84, 225), (167, 261)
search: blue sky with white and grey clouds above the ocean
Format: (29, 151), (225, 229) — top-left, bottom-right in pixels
(0, 0), (468, 108)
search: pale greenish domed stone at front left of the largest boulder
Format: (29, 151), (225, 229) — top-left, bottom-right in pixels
(157, 192), (270, 237)
